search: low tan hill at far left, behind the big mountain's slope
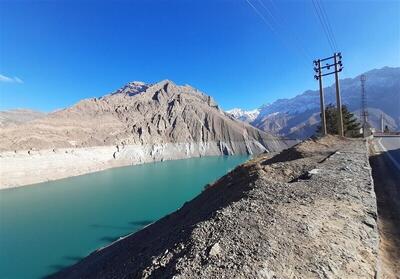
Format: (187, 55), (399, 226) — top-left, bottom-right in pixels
(0, 109), (46, 127)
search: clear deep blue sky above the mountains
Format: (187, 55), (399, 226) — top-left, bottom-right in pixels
(0, 0), (400, 111)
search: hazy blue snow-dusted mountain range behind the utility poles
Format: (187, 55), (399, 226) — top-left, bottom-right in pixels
(227, 67), (400, 139)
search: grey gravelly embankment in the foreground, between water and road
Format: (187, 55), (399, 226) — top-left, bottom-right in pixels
(53, 137), (378, 278)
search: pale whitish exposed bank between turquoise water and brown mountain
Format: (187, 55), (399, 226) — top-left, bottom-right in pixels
(0, 139), (287, 189)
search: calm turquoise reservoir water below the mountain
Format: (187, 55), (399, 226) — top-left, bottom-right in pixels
(0, 156), (248, 279)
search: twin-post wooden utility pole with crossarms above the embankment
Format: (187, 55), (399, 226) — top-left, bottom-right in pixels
(314, 52), (344, 137)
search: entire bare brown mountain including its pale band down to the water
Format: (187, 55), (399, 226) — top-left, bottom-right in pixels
(0, 80), (286, 187)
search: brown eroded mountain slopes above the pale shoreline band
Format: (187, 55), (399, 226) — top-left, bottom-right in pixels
(0, 81), (282, 153)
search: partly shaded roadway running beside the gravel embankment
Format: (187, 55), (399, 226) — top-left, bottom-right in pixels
(370, 136), (400, 279)
